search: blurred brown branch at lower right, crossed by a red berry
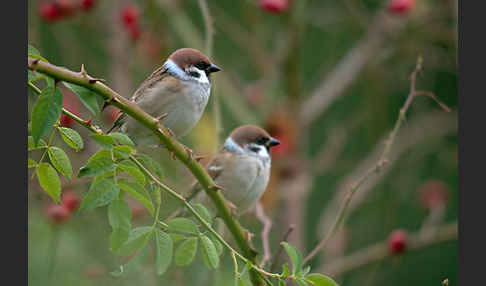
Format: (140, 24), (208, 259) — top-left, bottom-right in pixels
(320, 222), (457, 277)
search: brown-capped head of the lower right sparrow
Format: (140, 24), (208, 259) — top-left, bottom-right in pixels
(224, 125), (280, 158)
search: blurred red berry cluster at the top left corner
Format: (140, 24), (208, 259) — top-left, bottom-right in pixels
(39, 0), (96, 23)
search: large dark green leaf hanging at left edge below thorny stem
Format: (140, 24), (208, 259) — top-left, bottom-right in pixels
(32, 87), (62, 143)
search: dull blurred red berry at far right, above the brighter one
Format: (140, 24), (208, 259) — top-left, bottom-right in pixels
(418, 180), (449, 210)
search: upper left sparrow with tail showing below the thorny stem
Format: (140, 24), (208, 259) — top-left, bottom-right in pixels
(108, 48), (221, 146)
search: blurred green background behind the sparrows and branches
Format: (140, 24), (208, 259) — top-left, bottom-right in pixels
(28, 0), (458, 286)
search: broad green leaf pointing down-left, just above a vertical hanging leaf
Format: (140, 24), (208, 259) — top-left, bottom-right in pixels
(79, 179), (120, 211)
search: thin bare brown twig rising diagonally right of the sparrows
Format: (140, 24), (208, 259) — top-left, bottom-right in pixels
(303, 57), (422, 263)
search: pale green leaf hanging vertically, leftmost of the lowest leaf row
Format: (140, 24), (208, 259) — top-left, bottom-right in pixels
(108, 199), (132, 252)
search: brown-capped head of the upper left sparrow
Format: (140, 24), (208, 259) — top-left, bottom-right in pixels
(165, 48), (221, 83)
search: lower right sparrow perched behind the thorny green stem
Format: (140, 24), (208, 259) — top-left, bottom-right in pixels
(193, 125), (280, 216)
